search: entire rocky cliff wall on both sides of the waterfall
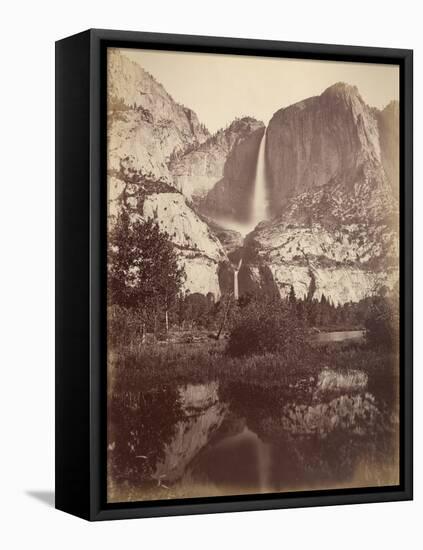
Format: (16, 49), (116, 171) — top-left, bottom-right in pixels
(108, 51), (399, 303)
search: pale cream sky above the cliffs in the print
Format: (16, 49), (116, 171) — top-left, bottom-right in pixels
(121, 49), (399, 132)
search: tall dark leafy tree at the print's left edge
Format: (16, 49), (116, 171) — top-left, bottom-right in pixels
(108, 208), (185, 334)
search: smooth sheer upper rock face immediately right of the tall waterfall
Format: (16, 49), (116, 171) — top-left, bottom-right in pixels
(266, 83), (390, 210)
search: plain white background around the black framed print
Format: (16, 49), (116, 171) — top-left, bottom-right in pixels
(0, 0), (423, 550)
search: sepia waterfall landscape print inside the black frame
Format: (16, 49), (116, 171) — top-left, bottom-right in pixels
(107, 48), (400, 502)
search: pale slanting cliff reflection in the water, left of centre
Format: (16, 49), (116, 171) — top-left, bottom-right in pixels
(153, 382), (227, 482)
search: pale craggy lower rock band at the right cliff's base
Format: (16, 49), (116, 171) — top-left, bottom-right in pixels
(248, 219), (398, 304)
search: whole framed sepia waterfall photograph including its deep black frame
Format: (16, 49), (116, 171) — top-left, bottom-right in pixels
(56, 30), (412, 520)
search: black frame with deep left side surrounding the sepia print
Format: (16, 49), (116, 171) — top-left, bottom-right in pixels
(56, 29), (413, 520)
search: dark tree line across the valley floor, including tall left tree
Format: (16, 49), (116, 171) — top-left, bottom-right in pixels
(108, 208), (398, 349)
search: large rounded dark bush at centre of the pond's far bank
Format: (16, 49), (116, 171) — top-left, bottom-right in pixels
(227, 298), (307, 360)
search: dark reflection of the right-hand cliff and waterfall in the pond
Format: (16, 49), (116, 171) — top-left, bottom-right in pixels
(217, 380), (398, 493)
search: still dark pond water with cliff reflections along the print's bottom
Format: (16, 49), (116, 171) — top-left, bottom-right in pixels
(109, 370), (398, 501)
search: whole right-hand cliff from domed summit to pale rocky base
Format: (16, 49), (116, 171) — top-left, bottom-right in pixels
(242, 84), (398, 303)
